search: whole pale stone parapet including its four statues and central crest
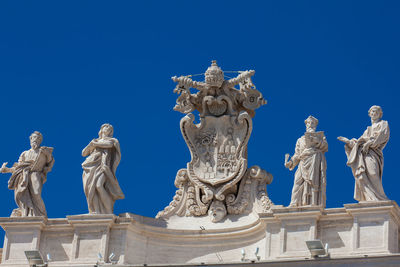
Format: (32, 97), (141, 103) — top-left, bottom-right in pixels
(0, 61), (400, 267)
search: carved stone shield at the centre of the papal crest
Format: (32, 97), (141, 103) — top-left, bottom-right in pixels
(181, 112), (252, 199)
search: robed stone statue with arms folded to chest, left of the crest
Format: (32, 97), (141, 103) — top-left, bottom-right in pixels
(82, 123), (125, 214)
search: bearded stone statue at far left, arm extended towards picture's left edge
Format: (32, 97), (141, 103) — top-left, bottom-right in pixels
(0, 131), (54, 217)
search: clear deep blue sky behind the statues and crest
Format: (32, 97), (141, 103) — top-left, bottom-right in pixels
(0, 1), (400, 242)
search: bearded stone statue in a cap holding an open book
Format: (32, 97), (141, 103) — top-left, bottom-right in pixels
(285, 116), (328, 207)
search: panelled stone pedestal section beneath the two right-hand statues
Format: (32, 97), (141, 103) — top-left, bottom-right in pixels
(260, 201), (400, 258)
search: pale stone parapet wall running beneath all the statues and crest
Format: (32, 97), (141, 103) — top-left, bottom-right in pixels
(0, 201), (400, 266)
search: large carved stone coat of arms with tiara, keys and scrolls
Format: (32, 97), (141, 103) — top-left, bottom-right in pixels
(157, 61), (272, 222)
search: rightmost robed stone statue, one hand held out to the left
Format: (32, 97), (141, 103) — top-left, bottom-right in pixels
(338, 106), (390, 201)
